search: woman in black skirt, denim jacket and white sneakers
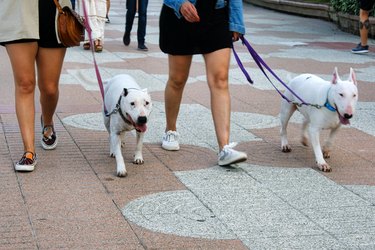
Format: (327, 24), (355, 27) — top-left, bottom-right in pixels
(159, 0), (247, 166)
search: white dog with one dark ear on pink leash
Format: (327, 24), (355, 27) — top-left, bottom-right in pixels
(103, 75), (152, 177)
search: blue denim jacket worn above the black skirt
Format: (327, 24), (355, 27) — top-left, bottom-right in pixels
(164, 0), (245, 35)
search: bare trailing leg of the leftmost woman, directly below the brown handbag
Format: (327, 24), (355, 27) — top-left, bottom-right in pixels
(37, 48), (66, 129)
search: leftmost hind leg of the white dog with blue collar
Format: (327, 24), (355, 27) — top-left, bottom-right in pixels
(280, 100), (297, 152)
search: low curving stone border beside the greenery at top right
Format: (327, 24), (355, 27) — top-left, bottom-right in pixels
(244, 0), (375, 39)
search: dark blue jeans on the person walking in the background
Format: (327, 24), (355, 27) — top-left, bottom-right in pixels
(125, 0), (148, 45)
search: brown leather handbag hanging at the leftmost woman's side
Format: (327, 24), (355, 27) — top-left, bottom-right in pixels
(54, 0), (85, 47)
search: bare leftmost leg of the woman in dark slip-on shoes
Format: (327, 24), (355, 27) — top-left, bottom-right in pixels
(6, 42), (38, 153)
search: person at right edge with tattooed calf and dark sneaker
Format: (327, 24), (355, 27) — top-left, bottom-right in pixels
(352, 0), (375, 54)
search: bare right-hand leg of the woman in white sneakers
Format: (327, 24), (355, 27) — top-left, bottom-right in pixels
(203, 48), (231, 150)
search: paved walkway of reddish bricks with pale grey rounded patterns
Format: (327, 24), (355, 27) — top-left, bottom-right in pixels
(0, 0), (375, 250)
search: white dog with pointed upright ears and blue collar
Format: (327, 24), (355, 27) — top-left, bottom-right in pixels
(280, 68), (358, 172)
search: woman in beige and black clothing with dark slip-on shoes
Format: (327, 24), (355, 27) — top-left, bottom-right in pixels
(0, 0), (71, 171)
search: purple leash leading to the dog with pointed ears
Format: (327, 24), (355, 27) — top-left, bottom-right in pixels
(232, 35), (326, 109)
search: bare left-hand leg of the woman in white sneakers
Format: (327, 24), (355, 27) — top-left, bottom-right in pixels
(164, 55), (193, 131)
